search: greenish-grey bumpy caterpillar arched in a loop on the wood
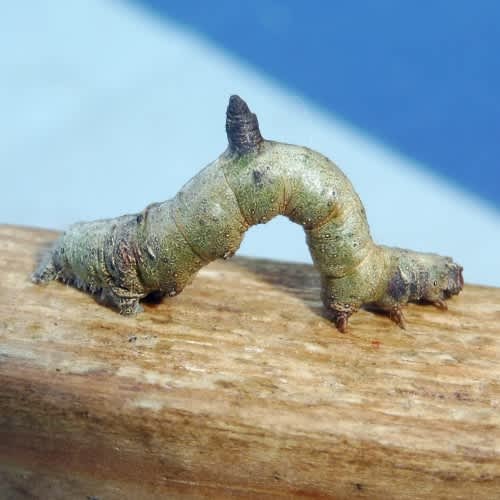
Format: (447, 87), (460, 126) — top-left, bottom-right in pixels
(33, 96), (463, 332)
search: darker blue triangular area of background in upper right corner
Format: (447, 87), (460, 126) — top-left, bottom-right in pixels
(137, 0), (500, 209)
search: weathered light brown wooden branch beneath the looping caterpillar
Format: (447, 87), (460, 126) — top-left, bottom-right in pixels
(0, 226), (500, 500)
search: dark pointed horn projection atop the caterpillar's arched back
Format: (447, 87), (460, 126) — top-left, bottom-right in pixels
(226, 95), (264, 155)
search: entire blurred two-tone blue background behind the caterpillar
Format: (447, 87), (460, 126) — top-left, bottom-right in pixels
(0, 0), (500, 286)
